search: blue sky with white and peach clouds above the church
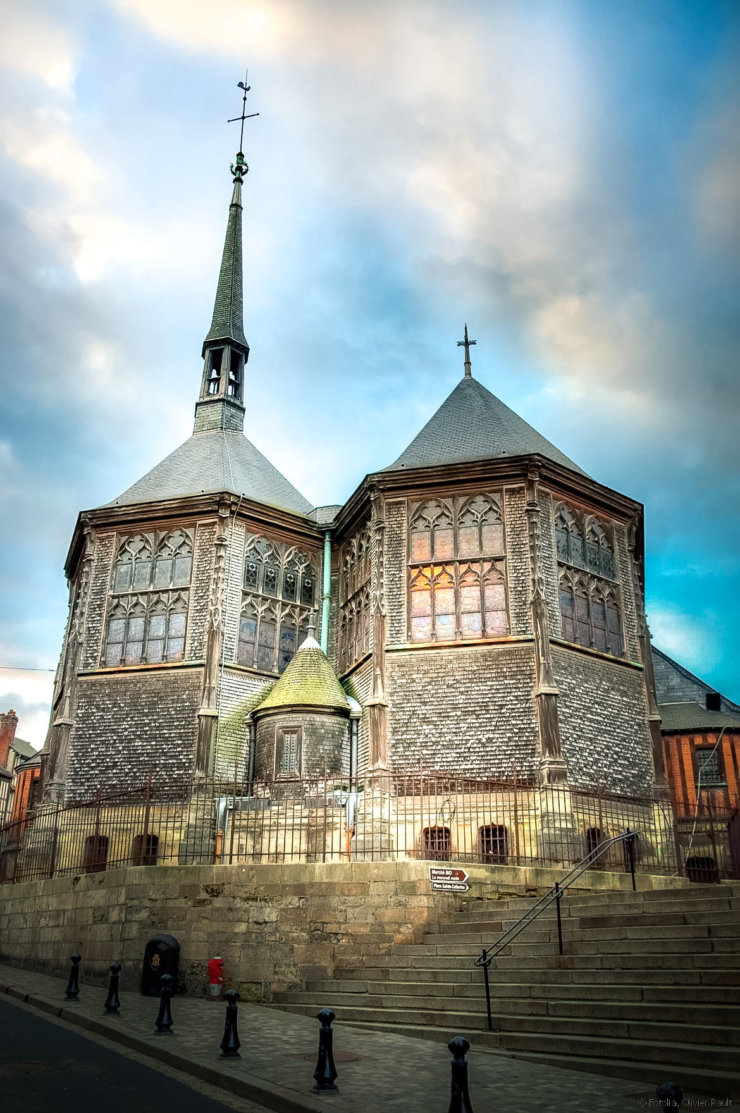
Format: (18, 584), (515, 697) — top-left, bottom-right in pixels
(0, 0), (740, 745)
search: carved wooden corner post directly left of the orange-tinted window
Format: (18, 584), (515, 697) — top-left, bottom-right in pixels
(367, 487), (388, 779)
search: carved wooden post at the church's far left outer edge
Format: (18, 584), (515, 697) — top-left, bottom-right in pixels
(41, 526), (95, 804)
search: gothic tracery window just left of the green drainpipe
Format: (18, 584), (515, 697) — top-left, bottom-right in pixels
(237, 535), (316, 672)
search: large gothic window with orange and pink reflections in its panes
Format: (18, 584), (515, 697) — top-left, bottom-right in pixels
(410, 494), (509, 641)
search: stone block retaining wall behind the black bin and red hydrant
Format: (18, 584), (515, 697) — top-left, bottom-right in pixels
(0, 861), (677, 1001)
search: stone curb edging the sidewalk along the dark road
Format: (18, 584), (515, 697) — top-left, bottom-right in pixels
(0, 982), (329, 1113)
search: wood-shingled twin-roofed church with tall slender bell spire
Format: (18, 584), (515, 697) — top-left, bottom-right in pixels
(43, 139), (664, 801)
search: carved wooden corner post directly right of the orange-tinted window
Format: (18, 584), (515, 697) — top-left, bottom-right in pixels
(525, 467), (566, 785)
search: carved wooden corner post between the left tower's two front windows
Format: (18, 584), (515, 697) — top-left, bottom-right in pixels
(196, 502), (230, 777)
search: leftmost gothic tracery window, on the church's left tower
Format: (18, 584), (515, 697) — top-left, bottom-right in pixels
(103, 530), (193, 668)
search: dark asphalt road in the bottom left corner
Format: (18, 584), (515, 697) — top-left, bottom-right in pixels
(0, 997), (265, 1113)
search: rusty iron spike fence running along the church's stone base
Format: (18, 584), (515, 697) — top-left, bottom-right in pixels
(0, 770), (740, 881)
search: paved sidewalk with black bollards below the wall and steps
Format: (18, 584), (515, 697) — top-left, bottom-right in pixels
(0, 965), (729, 1113)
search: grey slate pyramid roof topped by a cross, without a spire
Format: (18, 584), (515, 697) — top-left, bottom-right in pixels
(384, 375), (585, 475)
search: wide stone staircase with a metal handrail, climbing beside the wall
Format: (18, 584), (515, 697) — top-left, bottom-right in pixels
(275, 884), (740, 1096)
